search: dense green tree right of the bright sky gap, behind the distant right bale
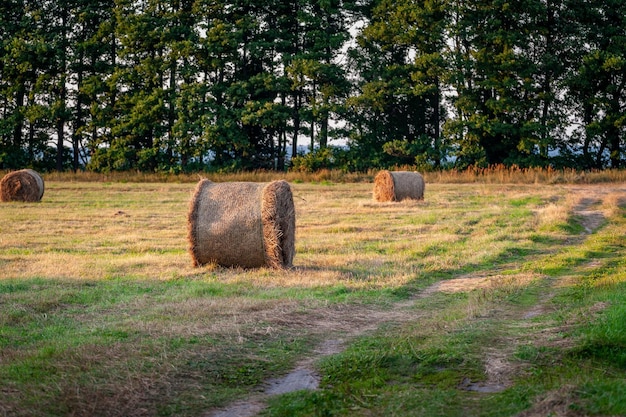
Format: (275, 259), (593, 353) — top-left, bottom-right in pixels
(348, 0), (447, 166)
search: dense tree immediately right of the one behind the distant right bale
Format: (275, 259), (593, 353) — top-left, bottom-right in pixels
(449, 0), (538, 164)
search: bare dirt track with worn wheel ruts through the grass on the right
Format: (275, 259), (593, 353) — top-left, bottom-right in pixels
(203, 184), (626, 417)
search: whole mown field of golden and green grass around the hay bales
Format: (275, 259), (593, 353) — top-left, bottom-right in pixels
(0, 176), (626, 417)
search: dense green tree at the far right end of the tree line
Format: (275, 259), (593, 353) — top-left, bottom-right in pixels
(564, 0), (626, 168)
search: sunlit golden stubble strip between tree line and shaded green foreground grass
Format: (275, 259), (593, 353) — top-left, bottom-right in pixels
(0, 181), (622, 288)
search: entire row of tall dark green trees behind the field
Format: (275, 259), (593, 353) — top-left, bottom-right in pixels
(0, 0), (626, 172)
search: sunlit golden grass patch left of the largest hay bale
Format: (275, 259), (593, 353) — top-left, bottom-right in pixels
(0, 182), (195, 279)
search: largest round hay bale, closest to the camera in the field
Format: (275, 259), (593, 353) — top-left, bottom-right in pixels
(188, 179), (296, 268)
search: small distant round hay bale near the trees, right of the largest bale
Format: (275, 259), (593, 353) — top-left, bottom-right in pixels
(373, 170), (425, 202)
